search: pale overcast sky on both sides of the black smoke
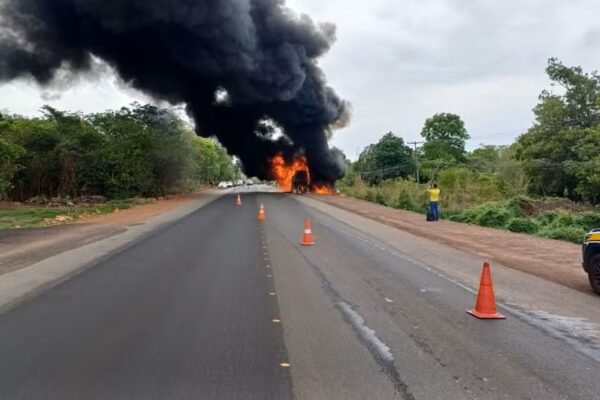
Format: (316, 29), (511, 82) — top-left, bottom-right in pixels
(0, 0), (600, 159)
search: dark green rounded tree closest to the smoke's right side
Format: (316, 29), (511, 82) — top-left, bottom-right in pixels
(355, 132), (414, 185)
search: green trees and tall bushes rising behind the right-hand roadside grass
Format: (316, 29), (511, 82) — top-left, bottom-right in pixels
(341, 58), (600, 205)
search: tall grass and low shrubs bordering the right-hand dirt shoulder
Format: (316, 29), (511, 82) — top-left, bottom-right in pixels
(340, 169), (600, 243)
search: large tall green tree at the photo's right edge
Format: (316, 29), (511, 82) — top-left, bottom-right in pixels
(516, 58), (600, 203)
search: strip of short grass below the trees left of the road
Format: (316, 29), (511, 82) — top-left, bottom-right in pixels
(0, 199), (153, 229)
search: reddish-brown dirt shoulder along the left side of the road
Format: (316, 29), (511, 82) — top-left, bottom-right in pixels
(0, 190), (210, 275)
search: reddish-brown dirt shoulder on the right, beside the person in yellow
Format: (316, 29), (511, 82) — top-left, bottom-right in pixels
(311, 195), (590, 293)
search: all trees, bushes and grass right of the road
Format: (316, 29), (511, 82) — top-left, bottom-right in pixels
(338, 59), (600, 243)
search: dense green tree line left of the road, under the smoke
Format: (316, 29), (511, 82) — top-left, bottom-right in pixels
(0, 104), (238, 201)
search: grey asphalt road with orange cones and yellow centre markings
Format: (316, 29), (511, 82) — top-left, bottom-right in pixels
(0, 193), (600, 399)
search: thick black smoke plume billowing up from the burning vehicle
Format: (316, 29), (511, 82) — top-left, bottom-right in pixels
(0, 0), (348, 183)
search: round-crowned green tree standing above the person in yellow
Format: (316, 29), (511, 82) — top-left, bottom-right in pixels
(421, 113), (470, 163)
